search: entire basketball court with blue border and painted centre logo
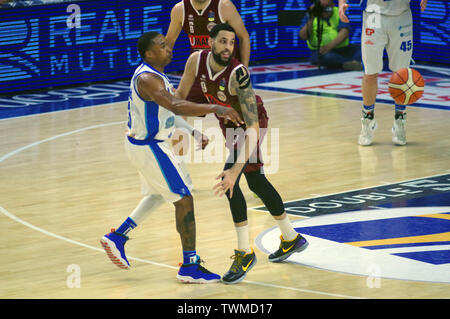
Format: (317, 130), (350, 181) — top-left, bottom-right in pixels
(0, 63), (450, 299)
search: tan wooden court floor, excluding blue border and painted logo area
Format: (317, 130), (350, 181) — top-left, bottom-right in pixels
(0, 90), (450, 299)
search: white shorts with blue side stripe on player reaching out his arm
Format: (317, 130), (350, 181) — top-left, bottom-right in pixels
(125, 137), (193, 203)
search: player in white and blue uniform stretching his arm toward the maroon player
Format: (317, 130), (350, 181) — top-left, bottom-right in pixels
(101, 32), (243, 283)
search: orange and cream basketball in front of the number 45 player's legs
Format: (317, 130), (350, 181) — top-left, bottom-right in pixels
(389, 68), (425, 105)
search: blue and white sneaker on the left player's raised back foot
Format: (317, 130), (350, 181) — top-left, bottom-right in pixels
(100, 228), (130, 269)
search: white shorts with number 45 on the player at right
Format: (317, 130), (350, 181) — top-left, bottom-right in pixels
(361, 10), (413, 74)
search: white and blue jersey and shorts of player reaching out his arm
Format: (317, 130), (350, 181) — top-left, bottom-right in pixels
(125, 63), (192, 203)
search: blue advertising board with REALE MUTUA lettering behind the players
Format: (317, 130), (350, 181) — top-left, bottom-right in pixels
(0, 0), (450, 94)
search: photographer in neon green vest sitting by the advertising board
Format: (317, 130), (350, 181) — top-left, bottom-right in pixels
(299, 0), (362, 70)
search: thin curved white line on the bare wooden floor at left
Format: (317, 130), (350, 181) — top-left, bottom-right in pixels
(0, 121), (362, 299)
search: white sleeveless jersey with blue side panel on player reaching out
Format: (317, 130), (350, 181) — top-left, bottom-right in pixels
(128, 63), (175, 141)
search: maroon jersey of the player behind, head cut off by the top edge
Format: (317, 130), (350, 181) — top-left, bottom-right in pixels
(183, 0), (224, 53)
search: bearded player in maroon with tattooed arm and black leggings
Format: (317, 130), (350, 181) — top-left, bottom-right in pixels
(175, 24), (308, 284)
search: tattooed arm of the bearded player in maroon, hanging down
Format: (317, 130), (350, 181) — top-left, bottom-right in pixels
(214, 66), (259, 197)
